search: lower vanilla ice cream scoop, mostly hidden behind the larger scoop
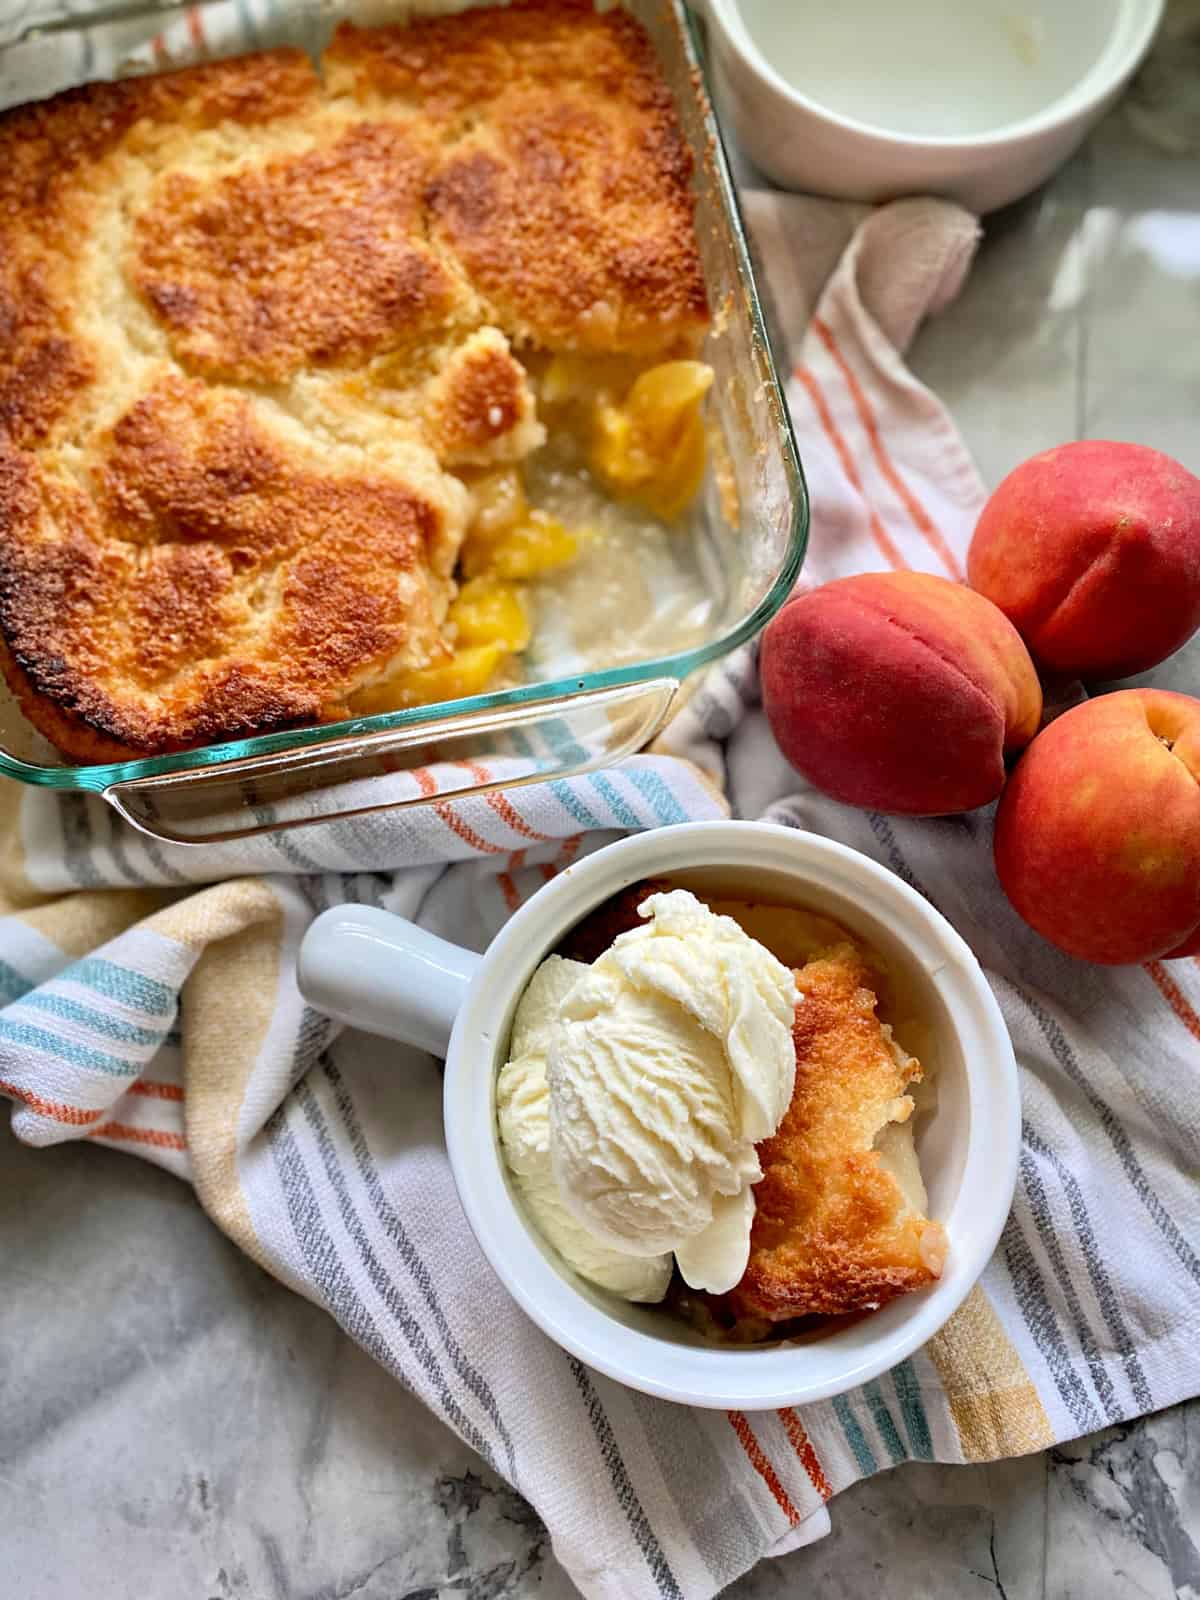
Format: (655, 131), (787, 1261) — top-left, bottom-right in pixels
(496, 955), (670, 1301)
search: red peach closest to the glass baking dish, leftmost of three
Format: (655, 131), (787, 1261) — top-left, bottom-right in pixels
(760, 573), (1042, 816)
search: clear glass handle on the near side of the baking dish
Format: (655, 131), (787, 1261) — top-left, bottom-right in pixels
(102, 677), (680, 845)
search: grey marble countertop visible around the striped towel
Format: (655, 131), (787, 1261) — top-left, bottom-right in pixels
(0, 0), (1200, 1600)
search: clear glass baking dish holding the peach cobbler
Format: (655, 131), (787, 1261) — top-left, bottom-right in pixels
(0, 0), (808, 843)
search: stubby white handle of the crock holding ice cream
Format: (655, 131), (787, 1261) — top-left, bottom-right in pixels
(296, 906), (480, 1056)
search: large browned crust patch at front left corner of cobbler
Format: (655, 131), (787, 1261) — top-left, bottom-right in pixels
(0, 378), (460, 760)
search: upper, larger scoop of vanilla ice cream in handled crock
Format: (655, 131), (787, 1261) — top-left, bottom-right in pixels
(546, 890), (797, 1294)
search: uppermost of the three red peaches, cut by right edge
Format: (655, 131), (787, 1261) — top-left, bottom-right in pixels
(966, 438), (1200, 678)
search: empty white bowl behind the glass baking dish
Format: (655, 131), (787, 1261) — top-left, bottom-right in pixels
(698, 0), (1165, 213)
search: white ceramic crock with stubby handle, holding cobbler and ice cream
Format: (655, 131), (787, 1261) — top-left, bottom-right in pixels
(299, 822), (1019, 1410)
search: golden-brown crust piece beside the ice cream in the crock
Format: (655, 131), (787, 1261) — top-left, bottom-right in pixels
(725, 944), (938, 1322)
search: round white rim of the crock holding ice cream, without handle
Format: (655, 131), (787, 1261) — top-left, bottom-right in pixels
(445, 821), (1021, 1411)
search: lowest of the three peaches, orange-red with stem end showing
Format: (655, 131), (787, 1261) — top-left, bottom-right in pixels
(995, 690), (1200, 966)
